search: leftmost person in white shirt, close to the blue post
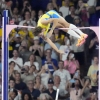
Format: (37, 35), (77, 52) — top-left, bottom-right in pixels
(9, 50), (23, 72)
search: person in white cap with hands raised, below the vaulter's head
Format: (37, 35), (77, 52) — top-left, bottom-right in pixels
(29, 37), (43, 57)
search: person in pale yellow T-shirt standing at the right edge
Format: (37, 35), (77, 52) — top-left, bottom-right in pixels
(87, 56), (99, 86)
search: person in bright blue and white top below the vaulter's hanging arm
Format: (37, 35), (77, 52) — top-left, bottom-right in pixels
(42, 49), (58, 74)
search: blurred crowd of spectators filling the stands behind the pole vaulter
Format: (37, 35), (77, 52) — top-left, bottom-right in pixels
(0, 0), (100, 100)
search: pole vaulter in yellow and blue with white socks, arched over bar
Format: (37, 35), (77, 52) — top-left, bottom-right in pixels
(34, 10), (88, 53)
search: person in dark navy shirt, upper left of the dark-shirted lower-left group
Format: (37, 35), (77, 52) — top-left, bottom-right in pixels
(15, 73), (27, 92)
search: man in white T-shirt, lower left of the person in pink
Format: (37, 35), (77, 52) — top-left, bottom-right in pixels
(53, 60), (71, 85)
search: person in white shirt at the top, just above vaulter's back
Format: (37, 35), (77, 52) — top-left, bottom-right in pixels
(59, 0), (69, 18)
